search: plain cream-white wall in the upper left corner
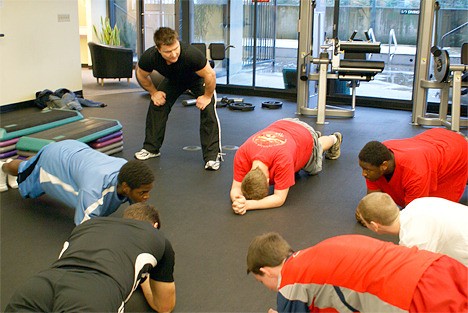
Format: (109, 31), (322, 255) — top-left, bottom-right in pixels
(0, 0), (83, 106)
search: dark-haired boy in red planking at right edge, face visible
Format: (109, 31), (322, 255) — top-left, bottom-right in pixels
(359, 128), (468, 208)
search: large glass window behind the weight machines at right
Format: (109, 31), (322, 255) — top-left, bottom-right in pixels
(326, 0), (468, 101)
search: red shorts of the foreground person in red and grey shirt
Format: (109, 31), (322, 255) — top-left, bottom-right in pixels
(409, 255), (468, 313)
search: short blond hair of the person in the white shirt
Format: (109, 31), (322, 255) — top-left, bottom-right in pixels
(356, 192), (400, 226)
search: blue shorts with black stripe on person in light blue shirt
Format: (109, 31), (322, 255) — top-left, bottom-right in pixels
(17, 149), (44, 198)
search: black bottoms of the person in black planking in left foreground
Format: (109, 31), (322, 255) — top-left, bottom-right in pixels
(5, 268), (123, 313)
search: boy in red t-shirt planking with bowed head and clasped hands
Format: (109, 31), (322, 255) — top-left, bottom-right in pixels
(230, 118), (343, 215)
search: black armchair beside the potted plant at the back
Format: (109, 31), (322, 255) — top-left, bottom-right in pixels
(88, 42), (133, 86)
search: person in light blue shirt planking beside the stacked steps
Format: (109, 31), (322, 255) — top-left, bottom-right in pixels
(0, 140), (154, 225)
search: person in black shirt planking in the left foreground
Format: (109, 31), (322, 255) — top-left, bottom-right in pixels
(5, 203), (176, 313)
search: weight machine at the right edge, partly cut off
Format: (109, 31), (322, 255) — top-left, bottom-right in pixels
(412, 0), (468, 131)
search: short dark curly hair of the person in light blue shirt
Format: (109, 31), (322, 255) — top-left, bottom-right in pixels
(117, 160), (154, 189)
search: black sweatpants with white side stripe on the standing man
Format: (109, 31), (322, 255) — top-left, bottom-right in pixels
(143, 78), (221, 162)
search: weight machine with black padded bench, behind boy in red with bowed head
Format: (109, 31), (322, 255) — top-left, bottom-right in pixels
(297, 1), (385, 124)
